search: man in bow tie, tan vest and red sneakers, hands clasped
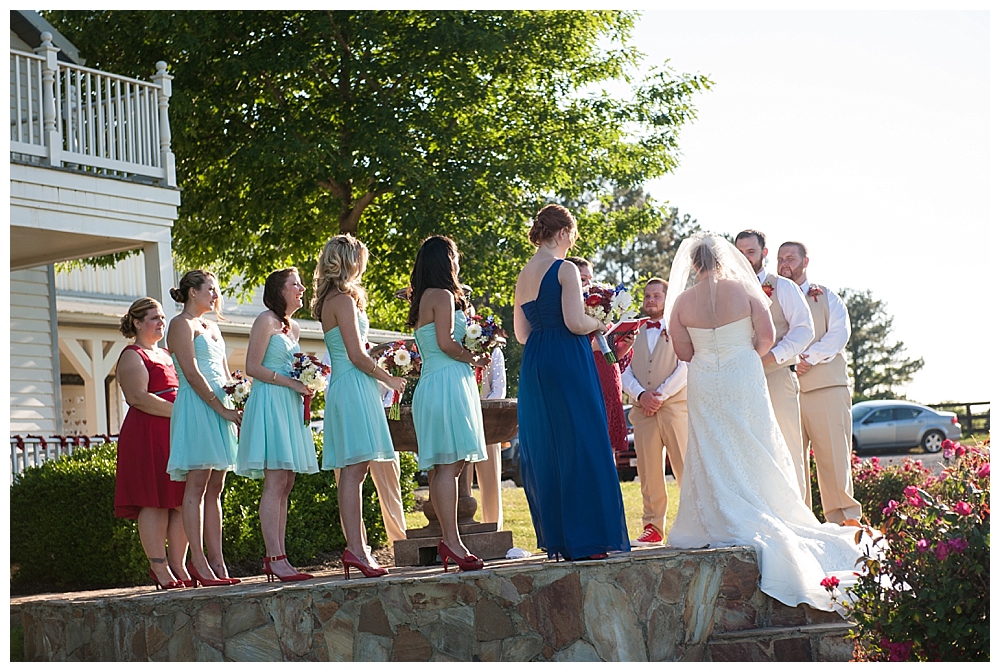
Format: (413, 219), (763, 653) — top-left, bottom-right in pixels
(622, 278), (688, 546)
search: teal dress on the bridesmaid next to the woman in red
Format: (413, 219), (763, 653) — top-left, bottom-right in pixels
(167, 334), (236, 481)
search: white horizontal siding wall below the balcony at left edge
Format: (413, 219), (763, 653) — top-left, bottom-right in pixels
(10, 267), (58, 436)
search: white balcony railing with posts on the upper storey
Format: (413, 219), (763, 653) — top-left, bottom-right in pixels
(10, 33), (177, 187)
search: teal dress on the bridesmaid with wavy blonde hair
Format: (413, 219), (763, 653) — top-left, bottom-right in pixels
(323, 308), (396, 469)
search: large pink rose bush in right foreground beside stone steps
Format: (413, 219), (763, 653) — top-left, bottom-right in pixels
(840, 441), (990, 661)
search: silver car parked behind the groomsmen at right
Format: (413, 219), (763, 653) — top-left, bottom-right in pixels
(851, 399), (962, 453)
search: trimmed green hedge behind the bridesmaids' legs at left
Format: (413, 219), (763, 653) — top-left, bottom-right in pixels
(10, 434), (417, 590)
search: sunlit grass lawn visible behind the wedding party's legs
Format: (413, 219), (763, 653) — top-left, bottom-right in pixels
(406, 477), (679, 553)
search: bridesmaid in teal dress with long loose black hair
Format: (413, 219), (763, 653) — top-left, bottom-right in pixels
(406, 236), (489, 571)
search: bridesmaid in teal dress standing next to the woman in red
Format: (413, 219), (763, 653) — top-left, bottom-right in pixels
(167, 270), (242, 586)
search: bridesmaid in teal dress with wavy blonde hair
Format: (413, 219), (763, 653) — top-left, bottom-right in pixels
(312, 235), (406, 578)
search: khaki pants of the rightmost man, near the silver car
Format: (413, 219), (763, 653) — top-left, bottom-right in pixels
(799, 385), (861, 523)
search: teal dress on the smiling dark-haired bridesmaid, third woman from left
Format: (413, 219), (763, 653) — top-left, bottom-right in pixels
(236, 334), (319, 478)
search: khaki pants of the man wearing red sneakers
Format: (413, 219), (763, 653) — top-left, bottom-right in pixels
(629, 400), (687, 536)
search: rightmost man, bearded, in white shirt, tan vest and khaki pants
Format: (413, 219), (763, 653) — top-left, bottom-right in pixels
(778, 242), (861, 525)
